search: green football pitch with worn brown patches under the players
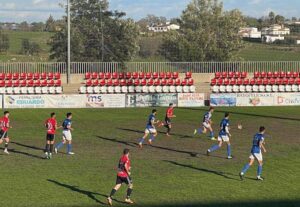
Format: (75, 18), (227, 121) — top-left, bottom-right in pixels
(0, 107), (300, 207)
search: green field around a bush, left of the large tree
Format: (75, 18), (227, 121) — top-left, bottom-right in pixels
(0, 31), (53, 62)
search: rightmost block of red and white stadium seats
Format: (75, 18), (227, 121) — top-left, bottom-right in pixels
(211, 71), (300, 93)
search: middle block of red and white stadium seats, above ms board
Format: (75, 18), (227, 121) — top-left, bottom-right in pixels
(79, 72), (196, 94)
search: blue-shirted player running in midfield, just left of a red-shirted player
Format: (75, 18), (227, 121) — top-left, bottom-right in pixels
(139, 109), (159, 148)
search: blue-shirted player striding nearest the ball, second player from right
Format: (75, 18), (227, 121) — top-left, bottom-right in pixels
(207, 113), (232, 159)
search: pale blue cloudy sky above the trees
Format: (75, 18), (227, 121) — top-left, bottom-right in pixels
(0, 0), (300, 22)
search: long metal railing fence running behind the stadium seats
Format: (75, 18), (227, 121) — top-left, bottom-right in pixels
(0, 61), (300, 74)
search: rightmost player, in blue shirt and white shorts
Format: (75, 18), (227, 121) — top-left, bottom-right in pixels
(240, 126), (267, 180)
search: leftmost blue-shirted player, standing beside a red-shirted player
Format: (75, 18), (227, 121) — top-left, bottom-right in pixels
(54, 113), (75, 155)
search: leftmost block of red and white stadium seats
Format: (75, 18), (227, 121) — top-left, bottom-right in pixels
(0, 72), (63, 94)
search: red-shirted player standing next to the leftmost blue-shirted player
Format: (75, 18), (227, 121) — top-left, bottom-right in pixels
(45, 113), (60, 159)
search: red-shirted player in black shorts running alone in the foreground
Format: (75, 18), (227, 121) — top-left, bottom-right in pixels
(107, 149), (133, 206)
